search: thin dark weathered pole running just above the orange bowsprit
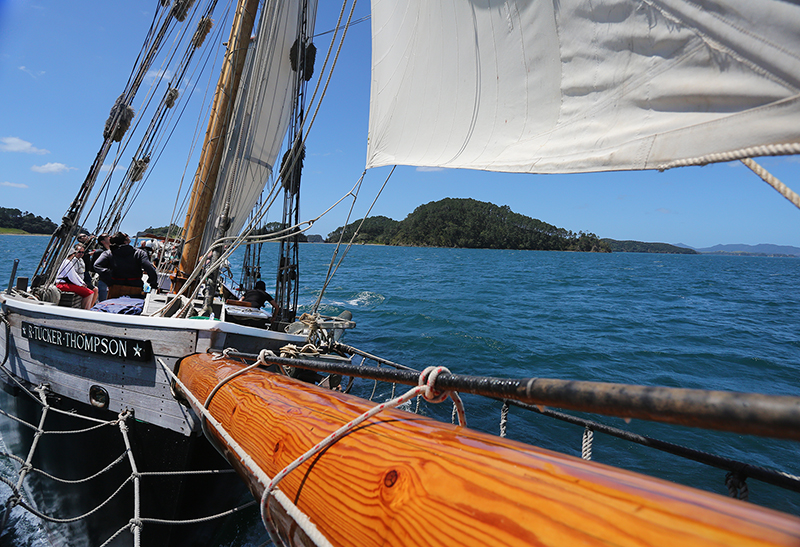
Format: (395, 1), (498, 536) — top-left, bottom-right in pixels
(231, 344), (800, 441)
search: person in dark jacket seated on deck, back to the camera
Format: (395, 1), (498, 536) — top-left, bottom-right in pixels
(94, 232), (158, 298)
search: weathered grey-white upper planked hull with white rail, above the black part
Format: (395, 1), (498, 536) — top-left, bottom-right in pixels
(0, 295), (305, 435)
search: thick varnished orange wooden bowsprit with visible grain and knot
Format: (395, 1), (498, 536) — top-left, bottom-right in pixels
(179, 355), (800, 547)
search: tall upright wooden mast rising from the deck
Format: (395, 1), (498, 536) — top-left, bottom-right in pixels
(176, 0), (258, 289)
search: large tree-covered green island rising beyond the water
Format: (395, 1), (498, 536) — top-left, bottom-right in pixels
(326, 198), (611, 252)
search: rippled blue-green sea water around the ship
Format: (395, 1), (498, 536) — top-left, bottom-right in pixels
(0, 236), (800, 547)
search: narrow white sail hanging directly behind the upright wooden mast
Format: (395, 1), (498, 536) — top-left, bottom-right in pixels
(201, 0), (317, 249)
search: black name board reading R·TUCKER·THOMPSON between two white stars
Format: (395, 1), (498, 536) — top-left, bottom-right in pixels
(22, 321), (153, 361)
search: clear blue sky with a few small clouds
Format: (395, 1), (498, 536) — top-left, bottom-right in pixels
(0, 0), (800, 248)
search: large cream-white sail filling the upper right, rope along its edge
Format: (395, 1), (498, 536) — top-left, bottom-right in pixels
(367, 0), (800, 173)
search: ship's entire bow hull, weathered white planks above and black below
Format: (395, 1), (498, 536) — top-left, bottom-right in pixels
(0, 295), (305, 546)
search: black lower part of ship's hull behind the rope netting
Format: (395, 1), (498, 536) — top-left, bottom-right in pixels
(5, 394), (250, 547)
